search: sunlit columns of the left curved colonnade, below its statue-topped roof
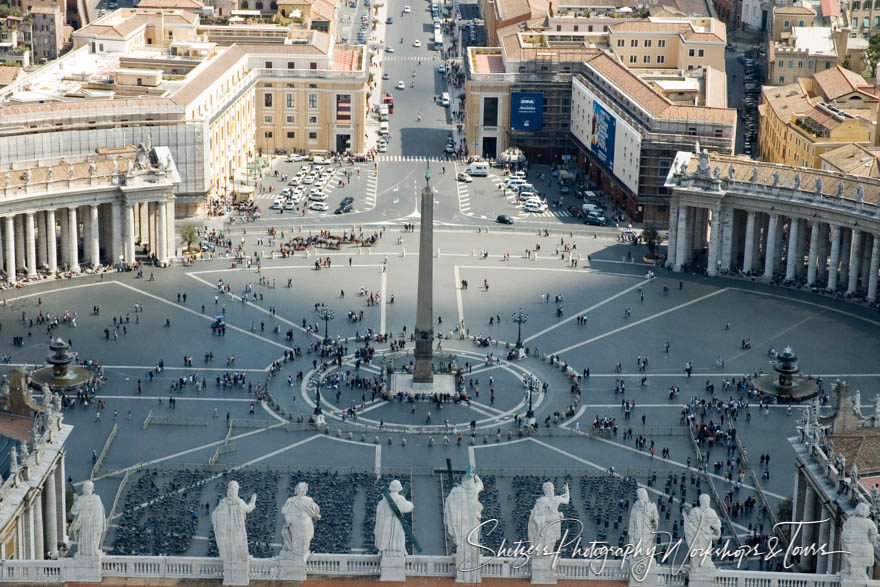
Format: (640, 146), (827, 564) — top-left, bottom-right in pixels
(0, 199), (175, 279)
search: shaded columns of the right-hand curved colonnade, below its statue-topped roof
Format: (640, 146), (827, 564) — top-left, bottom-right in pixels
(667, 200), (880, 302)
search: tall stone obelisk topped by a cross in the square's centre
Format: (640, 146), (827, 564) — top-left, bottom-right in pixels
(413, 163), (434, 387)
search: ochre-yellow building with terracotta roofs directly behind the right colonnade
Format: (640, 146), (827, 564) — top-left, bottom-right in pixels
(758, 66), (880, 168)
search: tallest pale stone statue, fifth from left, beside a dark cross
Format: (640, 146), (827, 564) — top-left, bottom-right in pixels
(443, 465), (483, 574)
